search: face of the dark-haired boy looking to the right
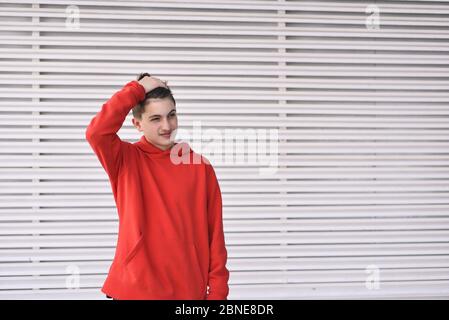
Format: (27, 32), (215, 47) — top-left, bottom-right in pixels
(132, 98), (178, 150)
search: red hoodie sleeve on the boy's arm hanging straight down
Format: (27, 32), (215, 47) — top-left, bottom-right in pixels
(206, 164), (229, 300)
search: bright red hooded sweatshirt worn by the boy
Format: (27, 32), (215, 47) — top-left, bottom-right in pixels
(86, 81), (229, 300)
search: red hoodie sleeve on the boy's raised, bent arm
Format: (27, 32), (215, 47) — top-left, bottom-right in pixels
(86, 81), (145, 180)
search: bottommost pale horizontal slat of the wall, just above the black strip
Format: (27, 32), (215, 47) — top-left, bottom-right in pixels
(0, 280), (449, 300)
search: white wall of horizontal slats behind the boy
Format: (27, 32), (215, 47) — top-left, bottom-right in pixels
(0, 0), (449, 299)
